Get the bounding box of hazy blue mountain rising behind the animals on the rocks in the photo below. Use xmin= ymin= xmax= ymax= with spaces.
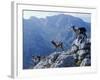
xmin=23 ymin=14 xmax=91 ymax=69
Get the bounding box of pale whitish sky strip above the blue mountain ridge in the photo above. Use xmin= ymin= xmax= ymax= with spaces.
xmin=23 ymin=10 xmax=91 ymax=23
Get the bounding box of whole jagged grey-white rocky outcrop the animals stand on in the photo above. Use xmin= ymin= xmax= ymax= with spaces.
xmin=33 ymin=39 xmax=91 ymax=69
